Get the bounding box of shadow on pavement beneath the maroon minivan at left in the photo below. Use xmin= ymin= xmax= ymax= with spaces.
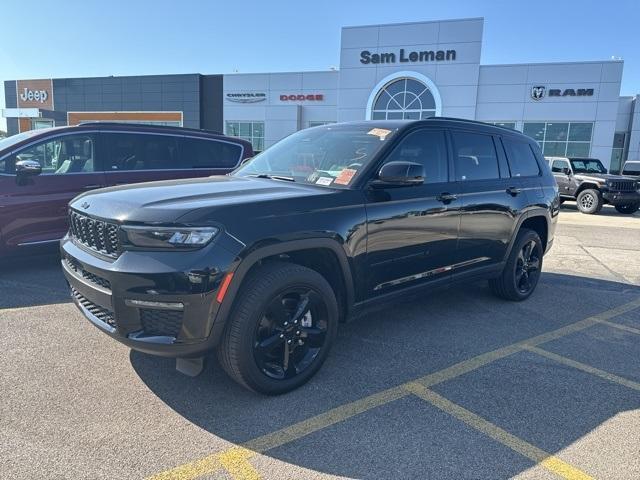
xmin=0 ymin=252 xmax=71 ymax=312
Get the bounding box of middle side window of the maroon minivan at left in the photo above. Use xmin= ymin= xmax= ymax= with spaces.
xmin=105 ymin=133 xmax=179 ymax=171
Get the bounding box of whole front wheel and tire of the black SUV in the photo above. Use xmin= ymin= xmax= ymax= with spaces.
xmin=218 ymin=262 xmax=338 ymax=395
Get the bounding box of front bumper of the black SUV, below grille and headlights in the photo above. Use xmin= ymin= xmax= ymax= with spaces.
xmin=60 ymin=237 xmax=235 ymax=357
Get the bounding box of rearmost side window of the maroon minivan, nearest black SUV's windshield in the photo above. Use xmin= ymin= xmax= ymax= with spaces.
xmin=180 ymin=138 xmax=242 ymax=168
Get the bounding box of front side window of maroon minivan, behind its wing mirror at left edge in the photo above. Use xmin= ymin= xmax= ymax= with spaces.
xmin=13 ymin=134 xmax=96 ymax=175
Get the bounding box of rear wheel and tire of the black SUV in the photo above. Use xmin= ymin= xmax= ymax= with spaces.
xmin=489 ymin=228 xmax=544 ymax=302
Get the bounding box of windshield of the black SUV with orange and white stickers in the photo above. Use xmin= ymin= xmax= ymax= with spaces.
xmin=233 ymin=123 xmax=396 ymax=187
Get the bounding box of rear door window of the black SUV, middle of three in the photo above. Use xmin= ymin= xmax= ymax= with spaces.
xmin=451 ymin=132 xmax=500 ymax=180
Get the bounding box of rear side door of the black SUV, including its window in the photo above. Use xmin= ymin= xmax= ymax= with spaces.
xmin=451 ymin=130 xmax=527 ymax=274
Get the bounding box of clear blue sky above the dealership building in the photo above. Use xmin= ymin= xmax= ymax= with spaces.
xmin=0 ymin=0 xmax=640 ymax=129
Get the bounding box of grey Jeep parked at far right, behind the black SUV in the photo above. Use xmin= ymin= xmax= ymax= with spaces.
xmin=546 ymin=157 xmax=640 ymax=214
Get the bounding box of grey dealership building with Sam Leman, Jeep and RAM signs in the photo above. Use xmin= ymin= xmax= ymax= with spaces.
xmin=3 ymin=18 xmax=640 ymax=171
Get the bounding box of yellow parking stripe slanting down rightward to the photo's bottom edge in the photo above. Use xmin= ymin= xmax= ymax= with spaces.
xmin=405 ymin=383 xmax=592 ymax=480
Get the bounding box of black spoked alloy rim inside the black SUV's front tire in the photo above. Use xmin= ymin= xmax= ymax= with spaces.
xmin=253 ymin=286 xmax=328 ymax=380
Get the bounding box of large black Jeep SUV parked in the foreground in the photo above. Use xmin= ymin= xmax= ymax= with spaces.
xmin=61 ymin=118 xmax=559 ymax=394
